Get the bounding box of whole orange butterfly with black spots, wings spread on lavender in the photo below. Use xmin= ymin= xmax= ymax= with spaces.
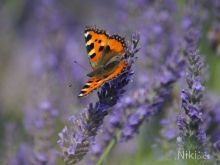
xmin=78 ymin=26 xmax=127 ymax=98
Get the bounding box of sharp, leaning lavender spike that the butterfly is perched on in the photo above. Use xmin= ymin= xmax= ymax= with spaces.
xmin=58 ymin=32 xmax=140 ymax=164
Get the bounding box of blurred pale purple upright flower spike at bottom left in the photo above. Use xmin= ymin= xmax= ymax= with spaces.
xmin=26 ymin=100 xmax=58 ymax=164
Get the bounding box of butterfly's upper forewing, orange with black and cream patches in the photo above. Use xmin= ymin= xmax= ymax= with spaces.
xmin=85 ymin=26 xmax=109 ymax=69
